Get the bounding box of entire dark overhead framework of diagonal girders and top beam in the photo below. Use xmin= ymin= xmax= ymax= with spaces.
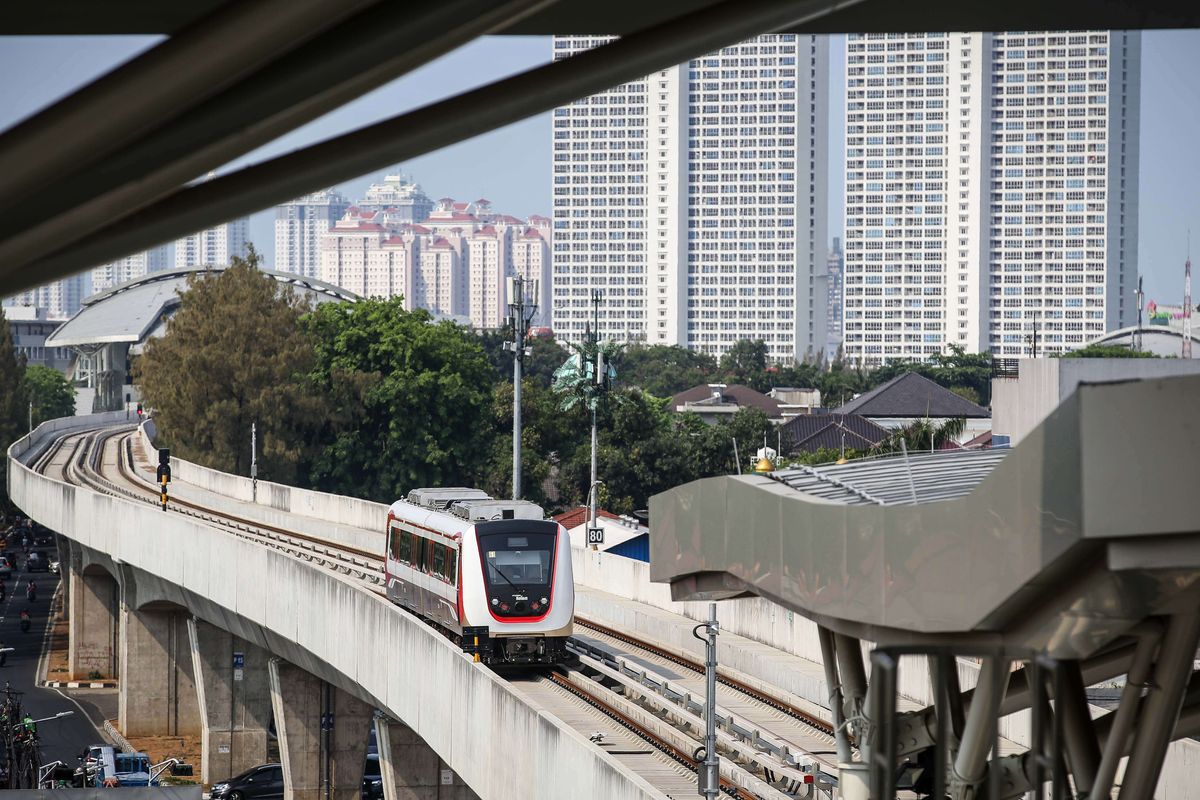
xmin=0 ymin=0 xmax=1200 ymax=302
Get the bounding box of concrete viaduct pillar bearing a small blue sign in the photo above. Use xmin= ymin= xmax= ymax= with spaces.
xmin=187 ymin=616 xmax=271 ymax=784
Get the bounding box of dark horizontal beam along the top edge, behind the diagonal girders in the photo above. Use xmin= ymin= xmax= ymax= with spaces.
xmin=7 ymin=0 xmax=1200 ymax=36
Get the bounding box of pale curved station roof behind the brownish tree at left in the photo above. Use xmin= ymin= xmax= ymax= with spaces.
xmin=46 ymin=266 xmax=359 ymax=347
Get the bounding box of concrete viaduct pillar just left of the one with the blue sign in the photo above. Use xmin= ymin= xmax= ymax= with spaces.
xmin=118 ymin=575 xmax=200 ymax=736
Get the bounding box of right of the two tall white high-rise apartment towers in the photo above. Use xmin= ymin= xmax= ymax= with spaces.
xmin=842 ymin=31 xmax=1141 ymax=365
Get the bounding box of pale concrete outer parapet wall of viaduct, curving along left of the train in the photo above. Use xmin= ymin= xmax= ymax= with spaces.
xmin=8 ymin=426 xmax=664 ymax=800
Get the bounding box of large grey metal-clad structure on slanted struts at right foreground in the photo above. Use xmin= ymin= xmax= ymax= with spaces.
xmin=650 ymin=377 xmax=1200 ymax=800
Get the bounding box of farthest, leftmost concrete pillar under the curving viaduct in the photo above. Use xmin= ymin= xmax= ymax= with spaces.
xmin=68 ymin=556 xmax=119 ymax=679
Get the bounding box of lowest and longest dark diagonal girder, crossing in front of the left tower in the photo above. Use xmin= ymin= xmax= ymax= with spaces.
xmin=0 ymin=0 xmax=858 ymax=293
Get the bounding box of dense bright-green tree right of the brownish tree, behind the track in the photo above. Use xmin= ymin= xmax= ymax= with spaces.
xmin=304 ymin=297 xmax=496 ymax=503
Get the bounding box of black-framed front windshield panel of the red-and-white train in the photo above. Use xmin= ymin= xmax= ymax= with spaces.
xmin=479 ymin=523 xmax=557 ymax=616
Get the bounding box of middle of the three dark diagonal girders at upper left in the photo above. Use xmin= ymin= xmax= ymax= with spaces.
xmin=0 ymin=0 xmax=551 ymax=271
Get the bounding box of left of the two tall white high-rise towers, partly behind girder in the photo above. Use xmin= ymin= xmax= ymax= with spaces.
xmin=553 ymin=34 xmax=828 ymax=361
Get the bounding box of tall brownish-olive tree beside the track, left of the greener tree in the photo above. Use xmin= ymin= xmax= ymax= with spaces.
xmin=134 ymin=249 xmax=328 ymax=483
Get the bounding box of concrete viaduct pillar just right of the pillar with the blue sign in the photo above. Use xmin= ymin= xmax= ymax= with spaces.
xmin=270 ymin=658 xmax=372 ymax=800
